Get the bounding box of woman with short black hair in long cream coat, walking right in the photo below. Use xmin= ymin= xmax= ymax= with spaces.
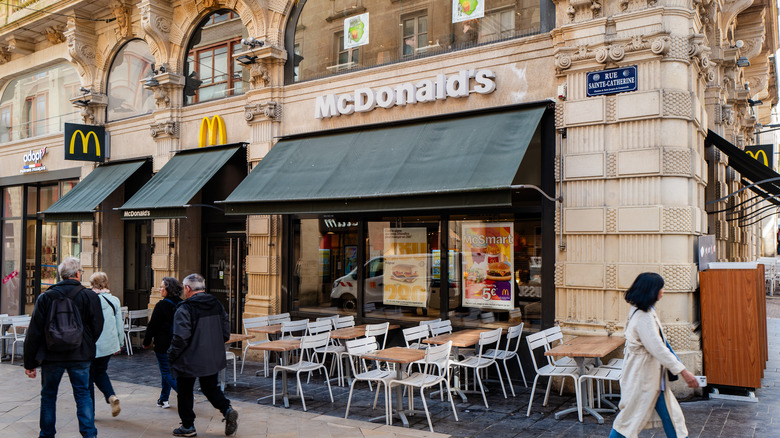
xmin=609 ymin=272 xmax=699 ymax=438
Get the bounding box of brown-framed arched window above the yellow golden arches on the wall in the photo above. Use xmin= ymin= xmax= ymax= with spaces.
xmin=184 ymin=9 xmax=249 ymax=105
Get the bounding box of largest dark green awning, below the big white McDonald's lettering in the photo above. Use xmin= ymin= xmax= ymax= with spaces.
xmin=222 ymin=104 xmax=547 ymax=214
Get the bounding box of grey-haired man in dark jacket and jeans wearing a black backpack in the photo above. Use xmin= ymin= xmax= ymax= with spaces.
xmin=24 ymin=257 xmax=103 ymax=438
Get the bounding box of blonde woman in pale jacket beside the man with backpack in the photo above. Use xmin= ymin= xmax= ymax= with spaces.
xmin=89 ymin=272 xmax=125 ymax=417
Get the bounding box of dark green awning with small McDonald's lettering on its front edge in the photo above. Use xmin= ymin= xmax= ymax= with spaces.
xmin=117 ymin=144 xmax=242 ymax=219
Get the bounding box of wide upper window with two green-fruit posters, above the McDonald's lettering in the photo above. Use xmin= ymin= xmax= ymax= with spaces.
xmin=285 ymin=0 xmax=545 ymax=83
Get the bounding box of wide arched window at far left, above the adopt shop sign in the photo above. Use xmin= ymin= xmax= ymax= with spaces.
xmin=0 ymin=62 xmax=81 ymax=143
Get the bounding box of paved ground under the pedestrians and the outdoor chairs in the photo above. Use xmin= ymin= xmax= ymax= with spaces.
xmin=0 ymin=302 xmax=780 ymax=438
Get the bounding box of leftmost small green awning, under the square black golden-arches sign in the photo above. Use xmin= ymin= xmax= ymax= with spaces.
xmin=43 ymin=160 xmax=146 ymax=222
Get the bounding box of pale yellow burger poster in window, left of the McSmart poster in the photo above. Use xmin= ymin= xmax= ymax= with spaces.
xmin=382 ymin=228 xmax=430 ymax=307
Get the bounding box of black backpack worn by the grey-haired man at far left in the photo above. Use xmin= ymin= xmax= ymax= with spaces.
xmin=46 ymin=287 xmax=84 ymax=352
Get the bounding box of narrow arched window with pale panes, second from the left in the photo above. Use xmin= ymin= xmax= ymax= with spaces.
xmin=106 ymin=40 xmax=154 ymax=122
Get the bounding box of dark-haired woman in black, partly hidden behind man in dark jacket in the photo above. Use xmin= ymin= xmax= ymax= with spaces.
xmin=144 ymin=277 xmax=183 ymax=409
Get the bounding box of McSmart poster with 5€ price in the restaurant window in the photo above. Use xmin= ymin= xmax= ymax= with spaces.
xmin=461 ymin=222 xmax=515 ymax=310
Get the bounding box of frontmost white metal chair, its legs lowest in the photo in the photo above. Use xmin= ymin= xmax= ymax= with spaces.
xmin=387 ymin=341 xmax=459 ymax=432
